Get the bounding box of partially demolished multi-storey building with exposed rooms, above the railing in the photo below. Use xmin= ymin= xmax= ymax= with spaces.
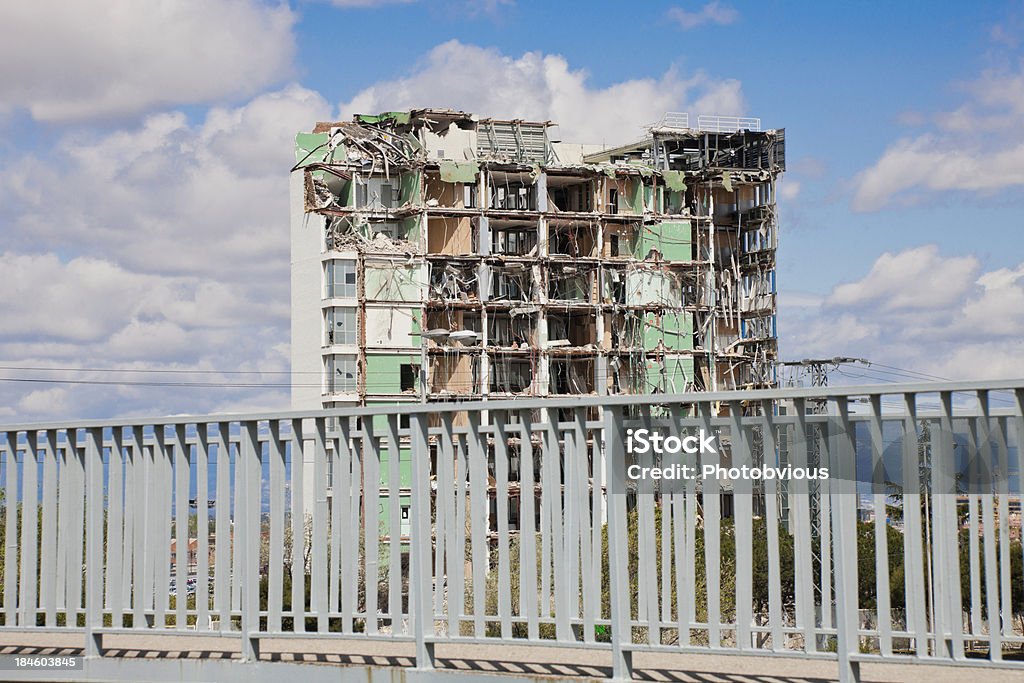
xmin=291 ymin=110 xmax=785 ymax=409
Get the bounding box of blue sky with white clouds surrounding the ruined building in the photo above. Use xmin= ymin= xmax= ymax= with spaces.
xmin=0 ymin=0 xmax=1024 ymax=422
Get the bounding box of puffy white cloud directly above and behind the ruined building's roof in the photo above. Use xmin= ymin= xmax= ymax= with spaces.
xmin=341 ymin=40 xmax=745 ymax=143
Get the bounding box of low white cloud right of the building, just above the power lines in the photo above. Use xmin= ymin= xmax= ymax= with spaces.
xmin=779 ymin=245 xmax=1024 ymax=381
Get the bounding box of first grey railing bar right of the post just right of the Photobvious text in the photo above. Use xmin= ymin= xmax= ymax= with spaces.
xmin=868 ymin=394 xmax=893 ymax=656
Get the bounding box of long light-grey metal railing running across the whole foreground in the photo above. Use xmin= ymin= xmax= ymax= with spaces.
xmin=0 ymin=381 xmax=1024 ymax=680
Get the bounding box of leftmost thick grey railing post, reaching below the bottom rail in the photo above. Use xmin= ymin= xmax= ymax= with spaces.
xmin=84 ymin=428 xmax=103 ymax=657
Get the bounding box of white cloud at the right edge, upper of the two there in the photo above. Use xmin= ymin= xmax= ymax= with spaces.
xmin=852 ymin=63 xmax=1024 ymax=211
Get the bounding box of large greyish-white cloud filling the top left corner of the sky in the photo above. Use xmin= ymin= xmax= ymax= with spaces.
xmin=0 ymin=0 xmax=296 ymax=122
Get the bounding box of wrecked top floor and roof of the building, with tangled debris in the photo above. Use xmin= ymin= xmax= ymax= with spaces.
xmin=295 ymin=109 xmax=785 ymax=178
